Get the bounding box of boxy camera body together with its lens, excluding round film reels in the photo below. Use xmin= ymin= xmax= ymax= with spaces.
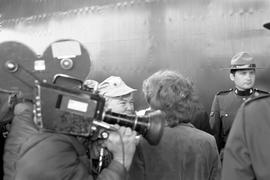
xmin=34 ymin=77 xmax=165 ymax=145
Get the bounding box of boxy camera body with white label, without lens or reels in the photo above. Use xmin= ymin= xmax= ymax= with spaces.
xmin=34 ymin=83 xmax=105 ymax=136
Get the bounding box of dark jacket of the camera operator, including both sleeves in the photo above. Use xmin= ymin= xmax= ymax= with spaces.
xmin=4 ymin=104 xmax=127 ymax=180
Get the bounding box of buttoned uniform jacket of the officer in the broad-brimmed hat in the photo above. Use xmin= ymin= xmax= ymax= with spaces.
xmin=209 ymin=89 xmax=268 ymax=151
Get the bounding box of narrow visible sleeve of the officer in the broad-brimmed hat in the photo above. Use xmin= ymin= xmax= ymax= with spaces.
xmin=209 ymin=95 xmax=225 ymax=151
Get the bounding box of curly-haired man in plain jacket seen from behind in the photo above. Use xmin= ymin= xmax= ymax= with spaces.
xmin=130 ymin=70 xmax=221 ymax=180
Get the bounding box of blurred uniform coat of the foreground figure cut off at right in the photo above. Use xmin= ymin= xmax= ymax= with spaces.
xmin=222 ymin=95 xmax=270 ymax=180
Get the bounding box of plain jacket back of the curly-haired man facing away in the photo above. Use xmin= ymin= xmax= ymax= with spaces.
xmin=130 ymin=123 xmax=220 ymax=180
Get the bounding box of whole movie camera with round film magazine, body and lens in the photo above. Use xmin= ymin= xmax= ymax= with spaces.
xmin=0 ymin=40 xmax=164 ymax=145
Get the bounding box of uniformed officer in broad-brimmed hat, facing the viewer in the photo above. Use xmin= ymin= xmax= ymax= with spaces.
xmin=209 ymin=52 xmax=268 ymax=159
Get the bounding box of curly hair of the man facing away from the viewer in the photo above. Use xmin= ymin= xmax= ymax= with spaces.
xmin=143 ymin=70 xmax=200 ymax=127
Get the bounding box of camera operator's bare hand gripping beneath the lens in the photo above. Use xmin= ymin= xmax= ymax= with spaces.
xmin=105 ymin=125 xmax=138 ymax=170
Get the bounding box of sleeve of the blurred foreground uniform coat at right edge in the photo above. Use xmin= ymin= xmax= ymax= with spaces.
xmin=222 ymin=105 xmax=256 ymax=180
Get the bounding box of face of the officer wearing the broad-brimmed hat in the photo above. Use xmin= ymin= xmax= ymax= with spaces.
xmin=230 ymin=69 xmax=255 ymax=90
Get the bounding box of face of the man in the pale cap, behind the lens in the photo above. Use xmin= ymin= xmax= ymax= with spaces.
xmin=105 ymin=93 xmax=135 ymax=114
